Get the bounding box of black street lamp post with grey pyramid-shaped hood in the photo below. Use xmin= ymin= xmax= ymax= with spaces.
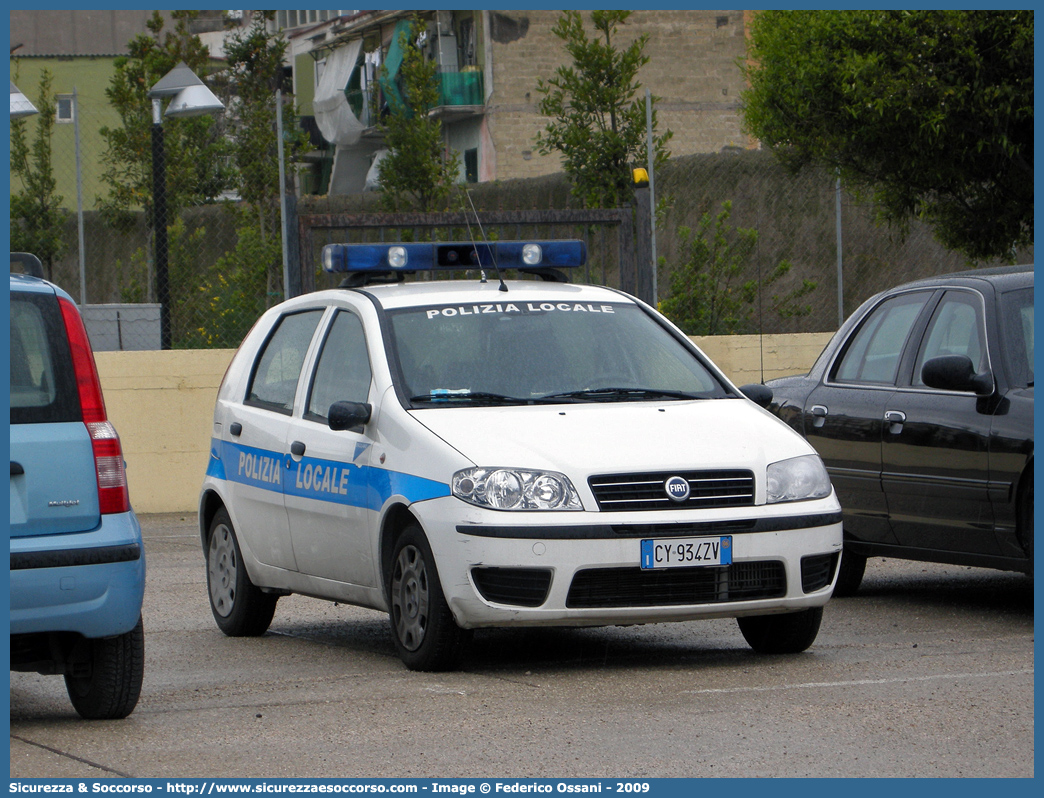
xmin=146 ymin=62 xmax=224 ymax=349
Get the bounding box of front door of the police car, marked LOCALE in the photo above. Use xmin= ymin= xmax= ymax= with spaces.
xmin=284 ymin=308 xmax=378 ymax=587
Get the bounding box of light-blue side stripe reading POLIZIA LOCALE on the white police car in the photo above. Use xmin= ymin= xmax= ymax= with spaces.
xmin=207 ymin=440 xmax=450 ymax=510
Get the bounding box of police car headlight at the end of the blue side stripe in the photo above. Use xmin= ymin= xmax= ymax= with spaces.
xmin=450 ymin=468 xmax=584 ymax=510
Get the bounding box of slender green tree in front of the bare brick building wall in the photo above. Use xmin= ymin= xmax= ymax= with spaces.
xmin=537 ymin=10 xmax=672 ymax=208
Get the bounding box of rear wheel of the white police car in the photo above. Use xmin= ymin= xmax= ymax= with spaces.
xmin=207 ymin=508 xmax=279 ymax=637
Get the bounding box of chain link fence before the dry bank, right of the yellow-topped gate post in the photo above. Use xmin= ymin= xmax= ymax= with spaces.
xmin=656 ymin=150 xmax=1033 ymax=334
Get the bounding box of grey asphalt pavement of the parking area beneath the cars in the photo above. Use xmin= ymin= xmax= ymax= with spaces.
xmin=10 ymin=515 xmax=1034 ymax=778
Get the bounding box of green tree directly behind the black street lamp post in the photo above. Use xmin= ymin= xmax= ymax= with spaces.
xmin=98 ymin=11 xmax=231 ymax=229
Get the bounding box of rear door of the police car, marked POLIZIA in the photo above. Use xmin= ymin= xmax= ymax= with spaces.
xmin=215 ymin=308 xmax=324 ymax=570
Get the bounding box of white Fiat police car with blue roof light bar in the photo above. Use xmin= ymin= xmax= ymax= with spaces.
xmin=199 ymin=241 xmax=841 ymax=670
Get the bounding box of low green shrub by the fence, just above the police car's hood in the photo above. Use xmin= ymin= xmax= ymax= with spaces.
xmin=660 ymin=201 xmax=816 ymax=335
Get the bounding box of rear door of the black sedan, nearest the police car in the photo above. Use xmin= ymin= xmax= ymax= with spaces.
xmin=803 ymin=291 xmax=931 ymax=543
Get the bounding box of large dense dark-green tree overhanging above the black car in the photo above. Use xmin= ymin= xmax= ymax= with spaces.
xmin=743 ymin=10 xmax=1034 ymax=259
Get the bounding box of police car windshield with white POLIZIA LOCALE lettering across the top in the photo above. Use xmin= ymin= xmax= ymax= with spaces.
xmin=388 ymin=301 xmax=729 ymax=407
